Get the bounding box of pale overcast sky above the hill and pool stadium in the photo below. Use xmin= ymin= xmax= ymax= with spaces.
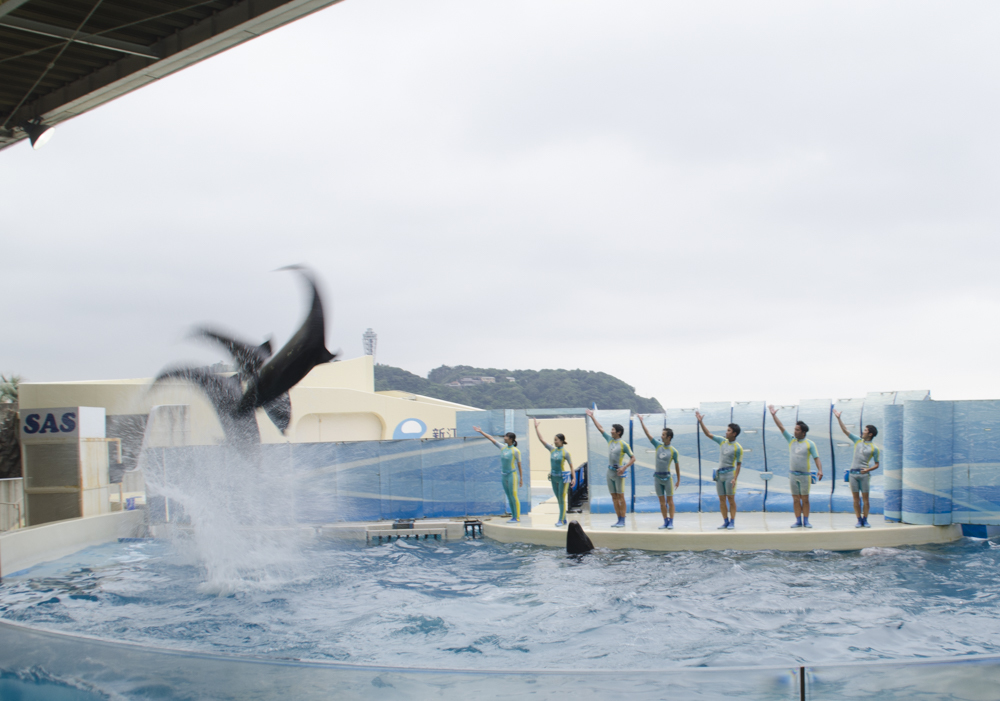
xmin=0 ymin=0 xmax=1000 ymax=408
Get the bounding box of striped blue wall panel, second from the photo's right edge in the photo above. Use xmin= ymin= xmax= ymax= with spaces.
xmin=901 ymin=401 xmax=955 ymax=526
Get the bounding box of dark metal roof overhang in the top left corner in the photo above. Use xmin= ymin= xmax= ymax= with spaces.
xmin=0 ymin=0 xmax=340 ymax=149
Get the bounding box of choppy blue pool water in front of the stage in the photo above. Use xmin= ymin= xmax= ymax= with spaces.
xmin=0 ymin=539 xmax=1000 ymax=670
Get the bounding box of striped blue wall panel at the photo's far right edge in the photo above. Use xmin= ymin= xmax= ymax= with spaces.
xmin=952 ymin=401 xmax=1000 ymax=526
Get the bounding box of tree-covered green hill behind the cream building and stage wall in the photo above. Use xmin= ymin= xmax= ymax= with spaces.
xmin=375 ymin=365 xmax=663 ymax=414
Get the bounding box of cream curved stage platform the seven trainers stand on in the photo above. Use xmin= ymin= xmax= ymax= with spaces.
xmin=483 ymin=499 xmax=962 ymax=551
